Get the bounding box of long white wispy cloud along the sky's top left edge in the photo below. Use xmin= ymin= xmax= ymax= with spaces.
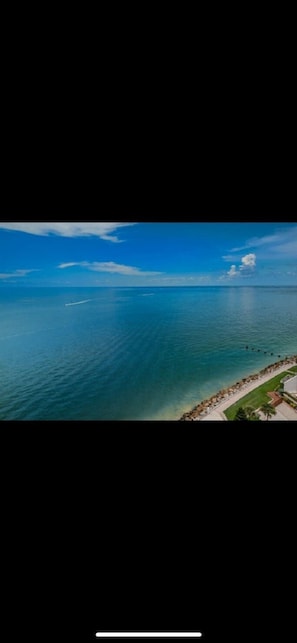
xmin=0 ymin=221 xmax=136 ymax=243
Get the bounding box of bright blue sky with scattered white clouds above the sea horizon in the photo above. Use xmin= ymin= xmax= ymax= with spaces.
xmin=0 ymin=222 xmax=297 ymax=286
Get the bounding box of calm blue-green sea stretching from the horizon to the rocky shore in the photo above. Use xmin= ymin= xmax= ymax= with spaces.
xmin=0 ymin=287 xmax=297 ymax=420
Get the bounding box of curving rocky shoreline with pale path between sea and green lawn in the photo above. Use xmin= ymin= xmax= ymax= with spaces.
xmin=178 ymin=355 xmax=297 ymax=422
